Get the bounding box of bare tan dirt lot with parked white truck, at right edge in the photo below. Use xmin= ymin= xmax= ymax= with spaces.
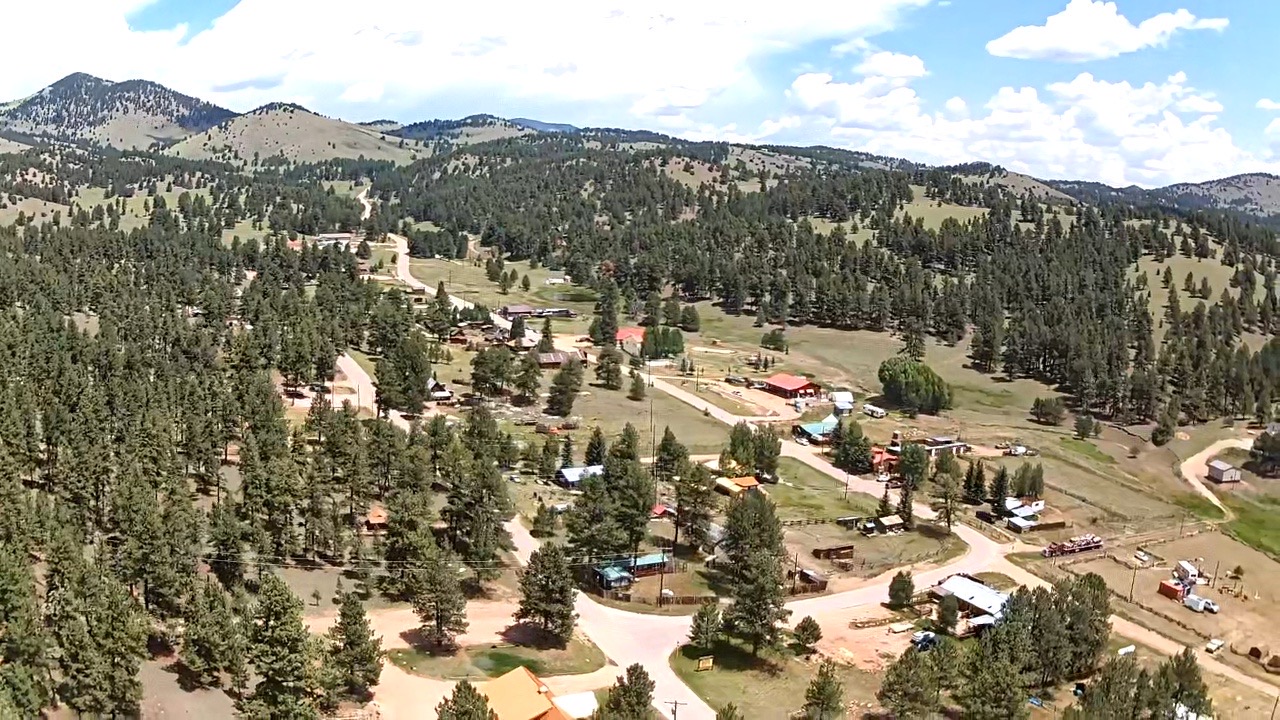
xmin=1071 ymin=532 xmax=1280 ymax=650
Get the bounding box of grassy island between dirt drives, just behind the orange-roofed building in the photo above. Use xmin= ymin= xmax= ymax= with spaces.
xmin=387 ymin=637 xmax=607 ymax=680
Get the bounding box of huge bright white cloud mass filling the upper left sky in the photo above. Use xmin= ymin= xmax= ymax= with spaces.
xmin=0 ymin=0 xmax=928 ymax=126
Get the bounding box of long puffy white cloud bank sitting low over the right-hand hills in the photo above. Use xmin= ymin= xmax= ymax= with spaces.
xmin=758 ymin=60 xmax=1264 ymax=187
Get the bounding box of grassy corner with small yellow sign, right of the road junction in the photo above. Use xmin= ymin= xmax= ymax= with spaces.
xmin=671 ymin=641 xmax=879 ymax=717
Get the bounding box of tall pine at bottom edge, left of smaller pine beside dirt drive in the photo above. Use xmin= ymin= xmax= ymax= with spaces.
xmin=244 ymin=574 xmax=319 ymax=719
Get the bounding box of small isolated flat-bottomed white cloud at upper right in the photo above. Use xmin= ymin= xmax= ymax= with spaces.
xmin=987 ymin=0 xmax=1228 ymax=63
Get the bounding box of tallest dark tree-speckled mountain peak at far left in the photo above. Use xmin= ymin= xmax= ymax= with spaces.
xmin=0 ymin=73 xmax=236 ymax=150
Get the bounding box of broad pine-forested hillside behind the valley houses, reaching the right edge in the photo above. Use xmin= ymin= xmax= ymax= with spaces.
xmin=347 ymin=136 xmax=1280 ymax=432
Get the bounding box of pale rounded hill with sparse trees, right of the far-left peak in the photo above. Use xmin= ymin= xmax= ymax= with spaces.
xmin=166 ymin=102 xmax=431 ymax=163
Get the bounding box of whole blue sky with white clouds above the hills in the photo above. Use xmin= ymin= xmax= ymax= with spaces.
xmin=0 ymin=0 xmax=1280 ymax=187
